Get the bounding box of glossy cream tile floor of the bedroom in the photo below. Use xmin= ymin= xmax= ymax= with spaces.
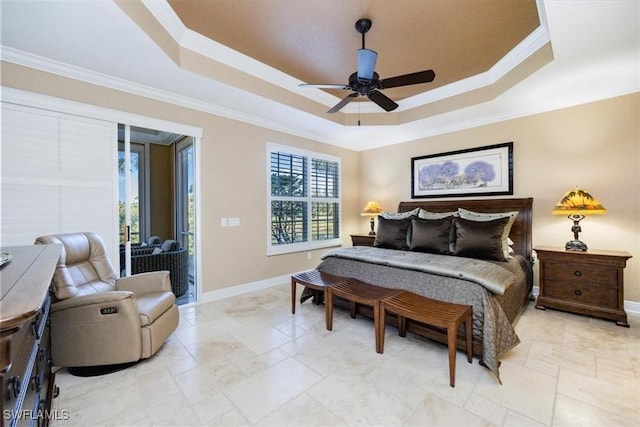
xmin=52 ymin=285 xmax=640 ymax=426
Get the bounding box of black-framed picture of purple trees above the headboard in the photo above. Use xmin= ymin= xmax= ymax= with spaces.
xmin=411 ymin=142 xmax=513 ymax=199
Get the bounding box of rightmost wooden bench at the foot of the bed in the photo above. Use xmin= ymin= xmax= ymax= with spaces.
xmin=374 ymin=291 xmax=473 ymax=387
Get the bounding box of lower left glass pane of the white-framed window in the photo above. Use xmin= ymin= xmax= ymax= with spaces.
xmin=271 ymin=201 xmax=307 ymax=245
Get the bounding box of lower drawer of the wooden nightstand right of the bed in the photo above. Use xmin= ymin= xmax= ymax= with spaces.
xmin=544 ymin=280 xmax=618 ymax=309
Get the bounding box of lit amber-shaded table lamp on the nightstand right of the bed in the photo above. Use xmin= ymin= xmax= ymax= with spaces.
xmin=551 ymin=188 xmax=607 ymax=251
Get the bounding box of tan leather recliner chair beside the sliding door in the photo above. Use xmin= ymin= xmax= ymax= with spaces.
xmin=36 ymin=232 xmax=179 ymax=367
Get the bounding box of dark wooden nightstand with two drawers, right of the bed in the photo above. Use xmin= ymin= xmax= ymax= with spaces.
xmin=534 ymin=246 xmax=631 ymax=327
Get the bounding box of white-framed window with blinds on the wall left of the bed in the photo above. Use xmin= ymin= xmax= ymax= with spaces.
xmin=267 ymin=144 xmax=341 ymax=255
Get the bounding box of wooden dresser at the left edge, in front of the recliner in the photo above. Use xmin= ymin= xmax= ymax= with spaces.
xmin=0 ymin=245 xmax=62 ymax=426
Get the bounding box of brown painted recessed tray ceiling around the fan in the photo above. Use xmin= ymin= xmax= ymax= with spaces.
xmin=169 ymin=0 xmax=540 ymax=100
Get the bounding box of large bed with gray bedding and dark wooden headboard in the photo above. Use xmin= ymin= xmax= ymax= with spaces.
xmin=310 ymin=198 xmax=533 ymax=378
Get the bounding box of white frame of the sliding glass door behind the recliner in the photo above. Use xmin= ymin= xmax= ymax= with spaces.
xmin=2 ymin=87 xmax=203 ymax=301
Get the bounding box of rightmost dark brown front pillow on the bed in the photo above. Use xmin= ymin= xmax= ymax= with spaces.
xmin=453 ymin=217 xmax=509 ymax=261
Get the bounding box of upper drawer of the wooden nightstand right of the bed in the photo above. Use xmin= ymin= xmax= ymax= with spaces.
xmin=542 ymin=262 xmax=618 ymax=288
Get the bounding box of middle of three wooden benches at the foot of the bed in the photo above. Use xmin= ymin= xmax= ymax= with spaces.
xmin=325 ymin=278 xmax=400 ymax=353
